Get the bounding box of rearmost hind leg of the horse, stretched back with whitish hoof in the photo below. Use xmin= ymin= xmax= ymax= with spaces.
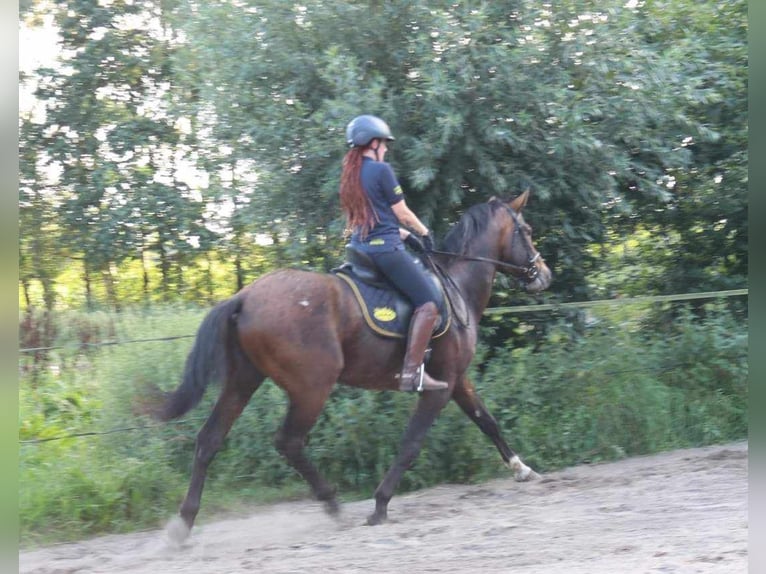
xmin=168 ymin=375 xmax=263 ymax=543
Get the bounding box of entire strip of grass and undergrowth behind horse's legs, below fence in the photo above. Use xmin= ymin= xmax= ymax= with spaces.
xmin=19 ymin=304 xmax=748 ymax=544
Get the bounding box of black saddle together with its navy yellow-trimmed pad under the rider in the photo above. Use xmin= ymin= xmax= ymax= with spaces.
xmin=331 ymin=245 xmax=452 ymax=339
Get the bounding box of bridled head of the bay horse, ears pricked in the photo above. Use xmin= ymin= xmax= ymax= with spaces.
xmin=498 ymin=190 xmax=553 ymax=293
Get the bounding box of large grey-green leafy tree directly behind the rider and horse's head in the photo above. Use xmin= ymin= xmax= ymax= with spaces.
xmin=170 ymin=1 xmax=745 ymax=299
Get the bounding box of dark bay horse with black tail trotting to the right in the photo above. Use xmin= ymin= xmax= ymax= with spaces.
xmin=154 ymin=191 xmax=551 ymax=541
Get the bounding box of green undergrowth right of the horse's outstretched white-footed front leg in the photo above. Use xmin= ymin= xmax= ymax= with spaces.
xmin=480 ymin=306 xmax=747 ymax=470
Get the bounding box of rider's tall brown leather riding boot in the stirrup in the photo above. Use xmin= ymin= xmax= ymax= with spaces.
xmin=399 ymin=302 xmax=449 ymax=392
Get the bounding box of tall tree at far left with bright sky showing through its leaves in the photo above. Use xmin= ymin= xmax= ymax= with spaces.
xmin=25 ymin=0 xmax=212 ymax=305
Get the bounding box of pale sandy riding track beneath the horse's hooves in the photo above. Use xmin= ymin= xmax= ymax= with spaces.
xmin=19 ymin=442 xmax=748 ymax=574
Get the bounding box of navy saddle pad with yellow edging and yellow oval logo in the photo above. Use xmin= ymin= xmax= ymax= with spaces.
xmin=333 ymin=268 xmax=451 ymax=339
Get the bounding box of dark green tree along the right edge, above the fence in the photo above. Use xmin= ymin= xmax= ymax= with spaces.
xmin=641 ymin=1 xmax=748 ymax=292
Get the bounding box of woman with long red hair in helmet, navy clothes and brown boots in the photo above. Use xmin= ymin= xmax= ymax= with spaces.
xmin=340 ymin=115 xmax=448 ymax=391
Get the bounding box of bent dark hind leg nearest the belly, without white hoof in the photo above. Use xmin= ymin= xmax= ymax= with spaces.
xmin=274 ymin=381 xmax=339 ymax=514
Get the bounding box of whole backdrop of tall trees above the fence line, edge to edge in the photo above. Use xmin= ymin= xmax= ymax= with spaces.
xmin=19 ymin=0 xmax=748 ymax=316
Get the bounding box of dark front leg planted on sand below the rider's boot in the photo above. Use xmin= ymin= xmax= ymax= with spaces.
xmin=367 ymin=390 xmax=449 ymax=526
